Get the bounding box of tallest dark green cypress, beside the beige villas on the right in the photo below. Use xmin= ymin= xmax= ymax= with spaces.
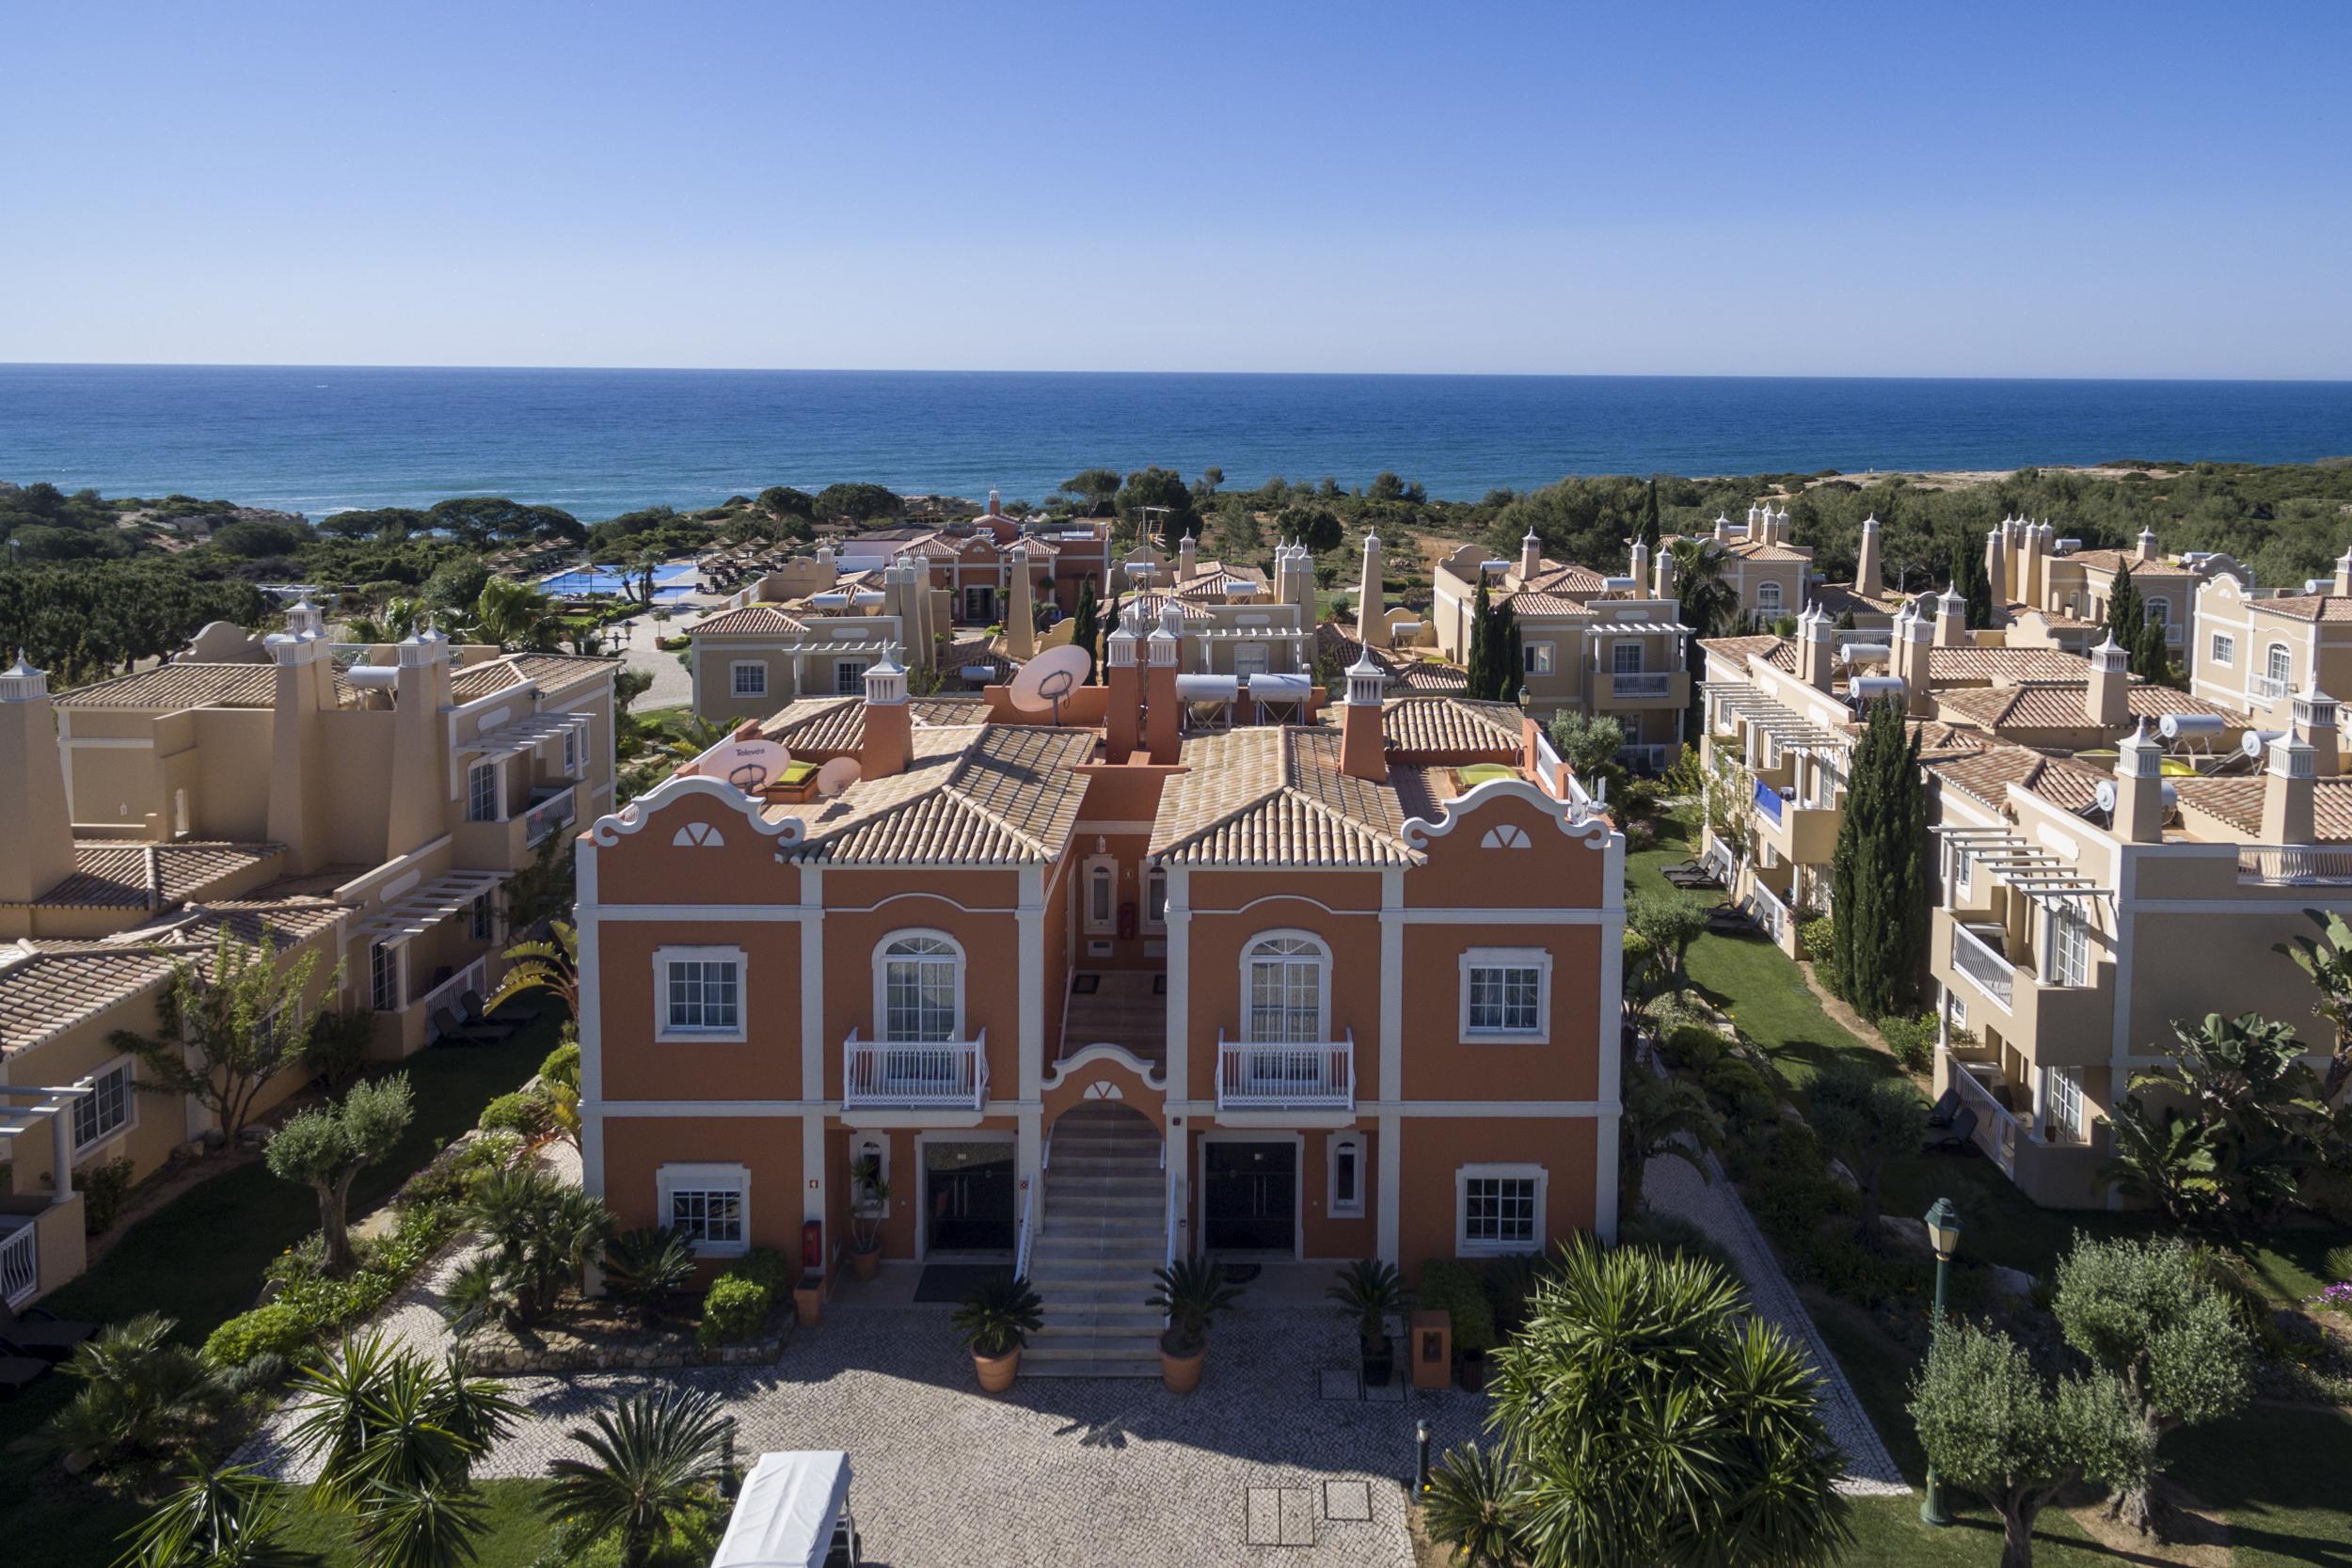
xmin=1830 ymin=701 xmax=1929 ymax=1018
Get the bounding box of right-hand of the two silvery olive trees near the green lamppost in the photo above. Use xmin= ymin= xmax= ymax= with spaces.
xmin=2051 ymin=1237 xmax=2253 ymax=1533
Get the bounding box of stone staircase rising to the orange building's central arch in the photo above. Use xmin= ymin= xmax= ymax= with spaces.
xmin=1021 ymin=1102 xmax=1167 ymax=1378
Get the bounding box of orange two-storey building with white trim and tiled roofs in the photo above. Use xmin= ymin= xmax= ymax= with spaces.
xmin=579 ymin=613 xmax=1623 ymax=1370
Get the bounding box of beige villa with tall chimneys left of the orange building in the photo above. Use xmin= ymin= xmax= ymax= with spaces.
xmin=0 ymin=604 xmax=619 ymax=1305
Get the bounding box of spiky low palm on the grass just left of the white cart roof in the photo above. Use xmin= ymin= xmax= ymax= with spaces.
xmin=539 ymin=1385 xmax=727 ymax=1568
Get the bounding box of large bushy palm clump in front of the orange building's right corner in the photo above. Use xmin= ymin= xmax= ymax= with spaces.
xmin=1486 ymin=1239 xmax=1853 ymax=1568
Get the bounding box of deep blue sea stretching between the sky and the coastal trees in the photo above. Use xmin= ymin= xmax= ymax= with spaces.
xmin=0 ymin=364 xmax=2352 ymax=519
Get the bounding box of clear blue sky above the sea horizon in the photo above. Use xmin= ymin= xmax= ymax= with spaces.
xmin=0 ymin=0 xmax=2352 ymax=378
